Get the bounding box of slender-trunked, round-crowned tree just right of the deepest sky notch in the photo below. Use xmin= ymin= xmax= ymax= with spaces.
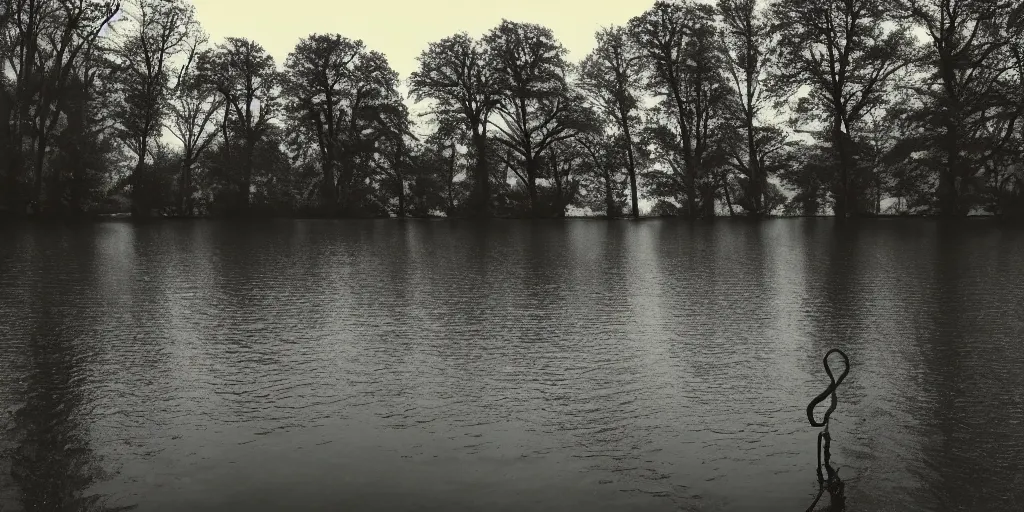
xmin=410 ymin=33 xmax=499 ymax=216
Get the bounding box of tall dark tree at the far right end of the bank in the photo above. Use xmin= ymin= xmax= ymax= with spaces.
xmin=897 ymin=0 xmax=1024 ymax=215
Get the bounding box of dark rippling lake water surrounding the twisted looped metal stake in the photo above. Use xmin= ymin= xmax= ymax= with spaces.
xmin=0 ymin=219 xmax=1024 ymax=511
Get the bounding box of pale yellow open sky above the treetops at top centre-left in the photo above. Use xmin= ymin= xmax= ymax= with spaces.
xmin=191 ymin=0 xmax=654 ymax=91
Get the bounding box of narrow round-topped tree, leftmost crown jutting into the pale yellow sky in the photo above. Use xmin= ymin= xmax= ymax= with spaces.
xmin=201 ymin=37 xmax=281 ymax=211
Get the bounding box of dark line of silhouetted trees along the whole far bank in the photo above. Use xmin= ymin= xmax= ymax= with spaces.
xmin=0 ymin=0 xmax=1024 ymax=219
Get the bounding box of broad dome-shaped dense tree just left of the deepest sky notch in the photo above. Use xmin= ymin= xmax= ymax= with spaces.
xmin=283 ymin=34 xmax=409 ymax=215
